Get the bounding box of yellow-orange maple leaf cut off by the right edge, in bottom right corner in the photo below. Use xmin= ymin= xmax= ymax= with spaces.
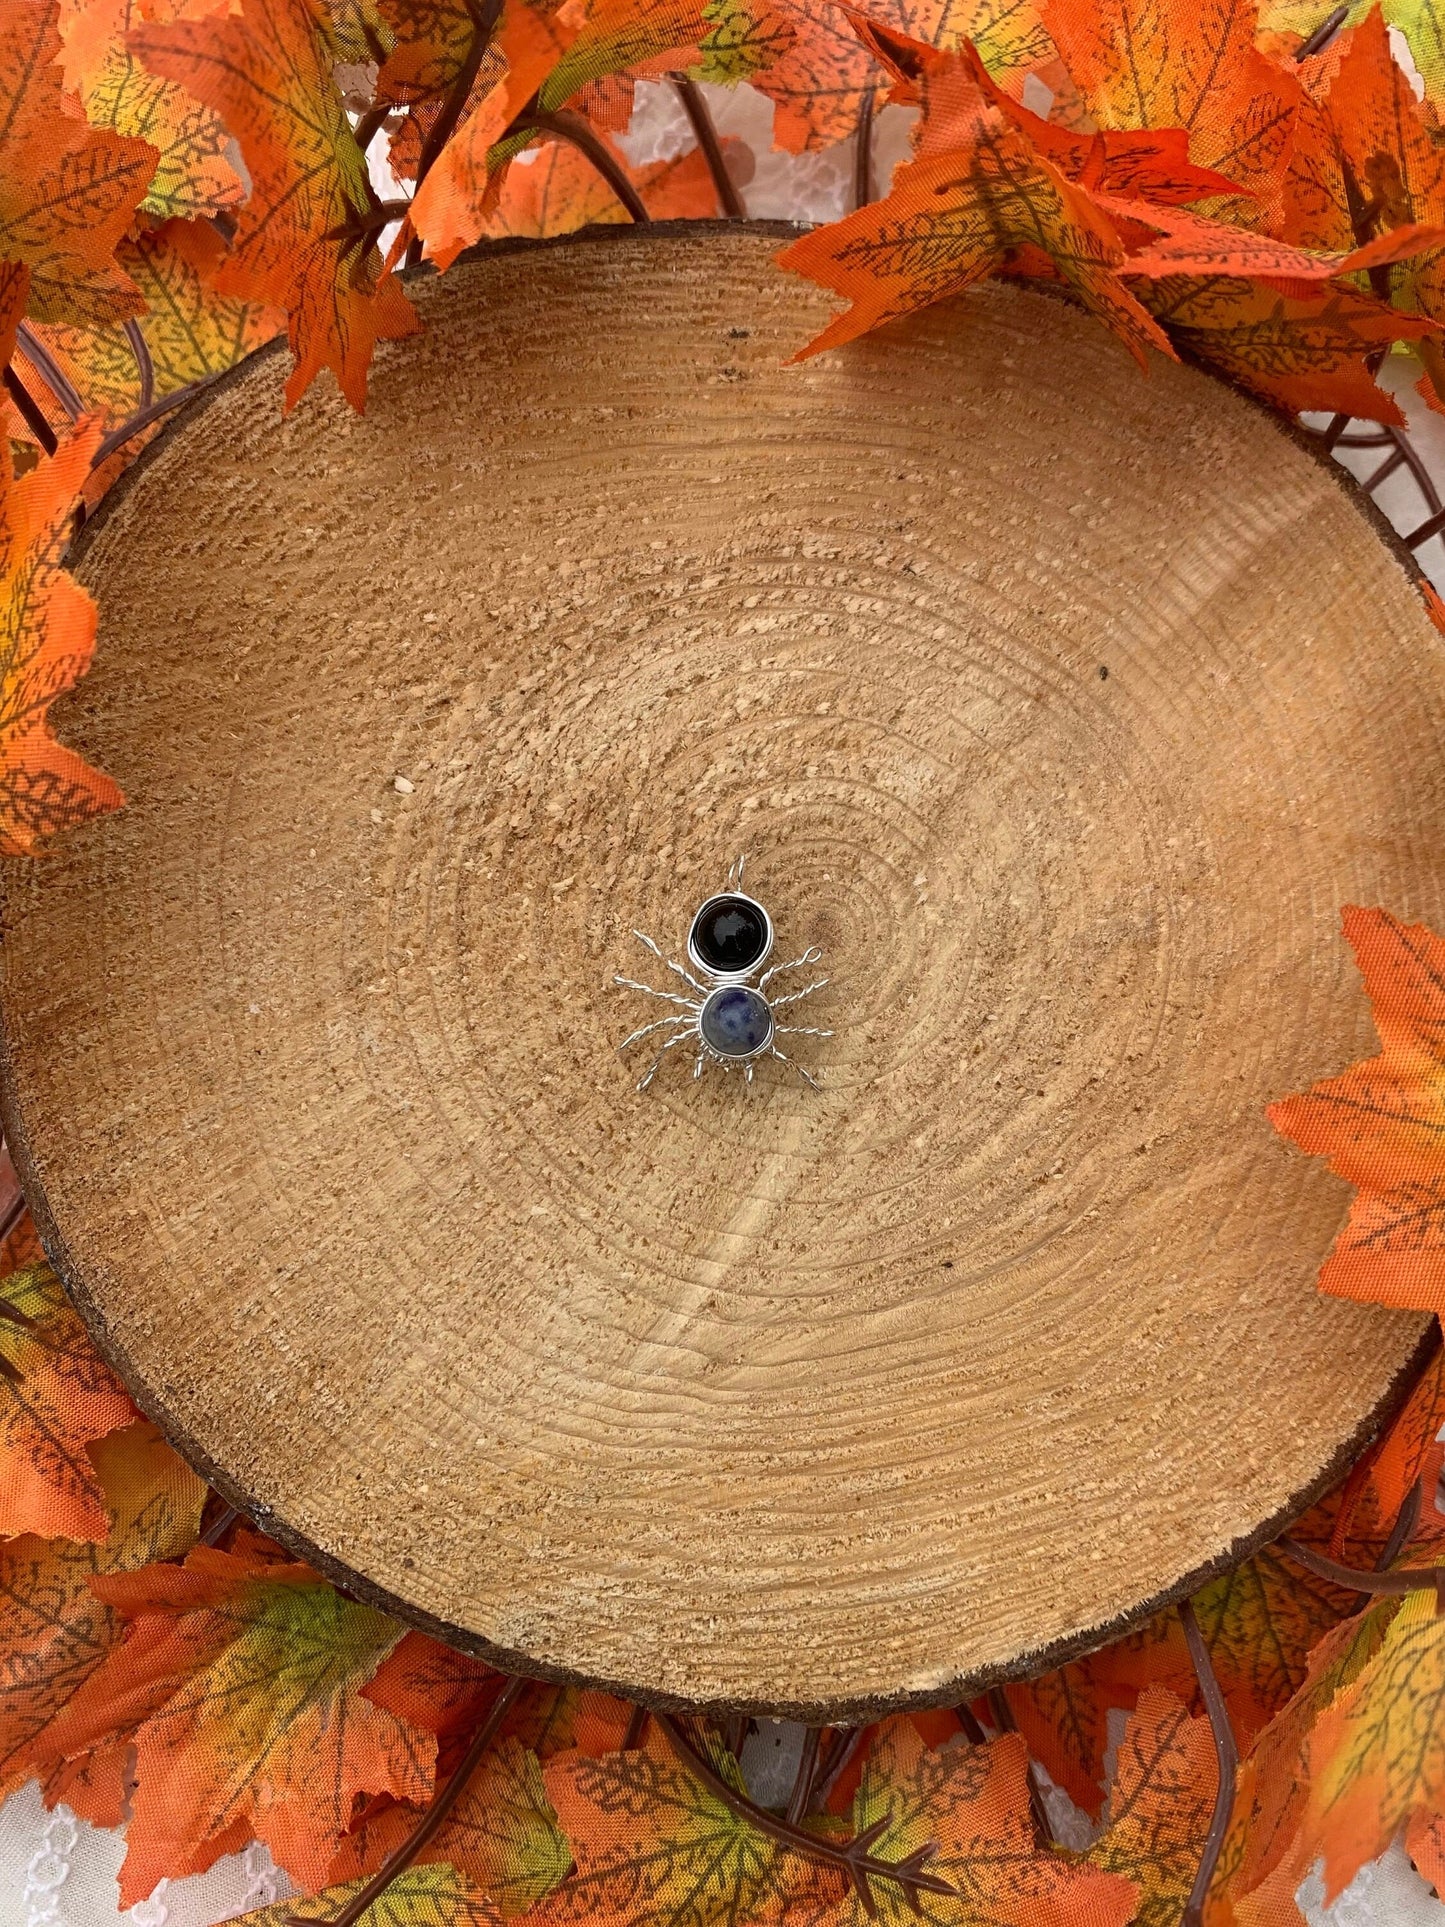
xmin=1302 ymin=1586 xmax=1445 ymax=1900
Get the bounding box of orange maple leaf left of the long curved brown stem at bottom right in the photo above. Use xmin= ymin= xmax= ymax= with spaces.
xmin=1087 ymin=1686 xmax=1220 ymax=1927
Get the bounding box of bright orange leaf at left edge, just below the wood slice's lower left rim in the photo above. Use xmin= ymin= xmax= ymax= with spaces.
xmin=0 ymin=1264 xmax=135 ymax=1540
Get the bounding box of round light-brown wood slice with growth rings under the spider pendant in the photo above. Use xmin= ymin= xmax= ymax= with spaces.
xmin=4 ymin=225 xmax=1445 ymax=1719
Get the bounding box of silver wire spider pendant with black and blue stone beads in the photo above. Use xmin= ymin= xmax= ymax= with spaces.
xmin=613 ymin=858 xmax=832 ymax=1091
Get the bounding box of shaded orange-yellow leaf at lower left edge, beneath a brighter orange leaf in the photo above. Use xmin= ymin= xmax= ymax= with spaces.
xmin=0 ymin=1420 xmax=206 ymax=1788
